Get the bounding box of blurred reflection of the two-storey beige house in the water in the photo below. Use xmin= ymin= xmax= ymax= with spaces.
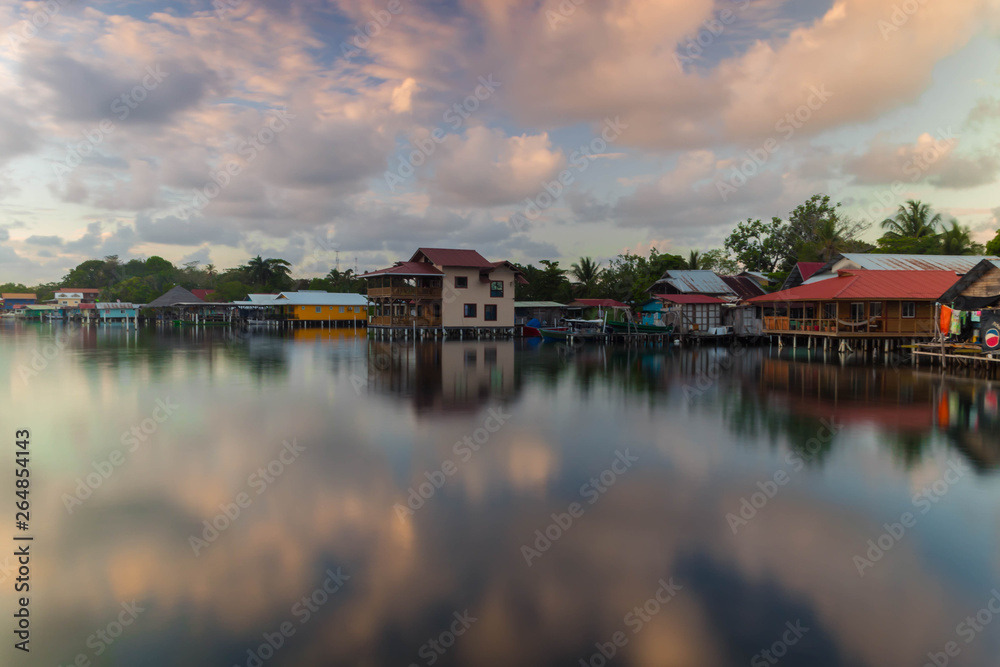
xmin=368 ymin=340 xmax=520 ymax=412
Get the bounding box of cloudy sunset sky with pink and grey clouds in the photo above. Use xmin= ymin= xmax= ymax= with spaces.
xmin=0 ymin=0 xmax=1000 ymax=285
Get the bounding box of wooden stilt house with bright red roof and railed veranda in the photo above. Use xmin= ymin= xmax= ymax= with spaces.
xmin=750 ymin=270 xmax=958 ymax=338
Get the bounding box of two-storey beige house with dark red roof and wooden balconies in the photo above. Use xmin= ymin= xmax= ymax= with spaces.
xmin=361 ymin=248 xmax=526 ymax=329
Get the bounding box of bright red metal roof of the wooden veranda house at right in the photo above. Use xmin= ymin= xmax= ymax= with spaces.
xmin=750 ymin=270 xmax=958 ymax=303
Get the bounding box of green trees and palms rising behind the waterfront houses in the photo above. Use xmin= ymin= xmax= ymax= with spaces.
xmin=0 ymin=194 xmax=1000 ymax=304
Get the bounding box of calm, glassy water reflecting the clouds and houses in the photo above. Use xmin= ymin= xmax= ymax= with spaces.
xmin=0 ymin=325 xmax=1000 ymax=667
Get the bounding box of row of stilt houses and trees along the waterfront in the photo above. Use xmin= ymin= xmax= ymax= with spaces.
xmin=0 ymin=196 xmax=1000 ymax=372
